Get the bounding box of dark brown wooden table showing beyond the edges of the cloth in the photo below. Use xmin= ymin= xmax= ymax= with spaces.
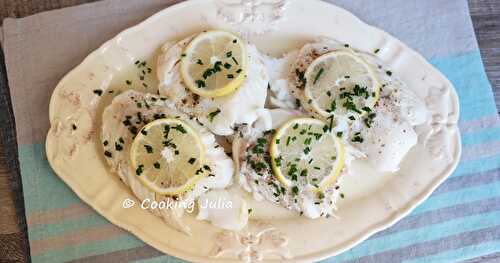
xmin=0 ymin=0 xmax=500 ymax=262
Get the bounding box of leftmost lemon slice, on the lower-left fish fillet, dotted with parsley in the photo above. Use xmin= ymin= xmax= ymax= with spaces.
xmin=130 ymin=118 xmax=209 ymax=195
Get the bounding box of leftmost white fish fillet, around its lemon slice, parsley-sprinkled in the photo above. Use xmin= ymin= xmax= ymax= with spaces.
xmin=101 ymin=90 xmax=234 ymax=234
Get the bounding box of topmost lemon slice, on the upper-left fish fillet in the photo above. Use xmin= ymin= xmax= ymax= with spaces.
xmin=181 ymin=31 xmax=247 ymax=97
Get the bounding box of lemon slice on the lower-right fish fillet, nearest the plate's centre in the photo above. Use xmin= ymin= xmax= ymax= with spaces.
xmin=269 ymin=118 xmax=344 ymax=192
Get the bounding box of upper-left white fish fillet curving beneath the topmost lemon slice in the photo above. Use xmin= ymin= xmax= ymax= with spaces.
xmin=157 ymin=37 xmax=269 ymax=135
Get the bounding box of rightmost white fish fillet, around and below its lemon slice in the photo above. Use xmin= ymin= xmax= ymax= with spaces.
xmin=289 ymin=39 xmax=429 ymax=172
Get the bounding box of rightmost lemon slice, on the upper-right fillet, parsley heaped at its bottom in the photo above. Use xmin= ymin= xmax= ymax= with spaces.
xmin=304 ymin=50 xmax=380 ymax=119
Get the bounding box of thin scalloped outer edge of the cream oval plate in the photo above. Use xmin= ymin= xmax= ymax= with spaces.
xmin=45 ymin=0 xmax=462 ymax=262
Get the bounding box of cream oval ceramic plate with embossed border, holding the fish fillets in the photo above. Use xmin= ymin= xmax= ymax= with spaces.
xmin=46 ymin=0 xmax=461 ymax=262
